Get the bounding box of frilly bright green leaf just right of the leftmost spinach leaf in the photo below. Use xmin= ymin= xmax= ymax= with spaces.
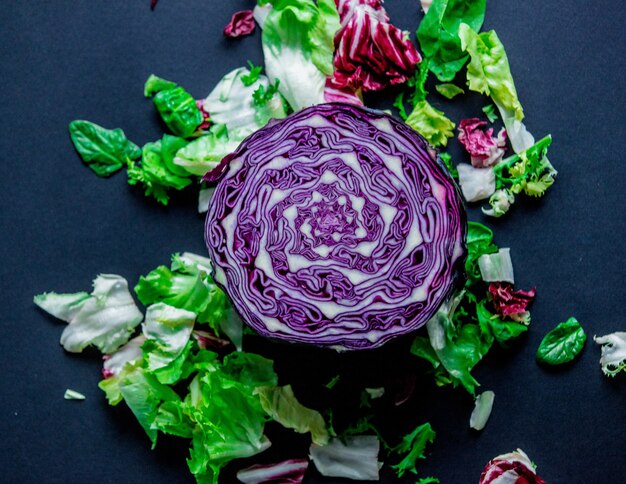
xmin=128 ymin=140 xmax=191 ymax=205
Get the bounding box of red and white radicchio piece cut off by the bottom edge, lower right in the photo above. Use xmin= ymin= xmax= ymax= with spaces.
xmin=478 ymin=449 xmax=546 ymax=484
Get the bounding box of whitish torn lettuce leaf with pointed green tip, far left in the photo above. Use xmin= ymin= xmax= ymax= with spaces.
xmin=34 ymin=274 xmax=143 ymax=353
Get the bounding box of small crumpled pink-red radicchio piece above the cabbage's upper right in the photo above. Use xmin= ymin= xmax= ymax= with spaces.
xmin=459 ymin=118 xmax=506 ymax=168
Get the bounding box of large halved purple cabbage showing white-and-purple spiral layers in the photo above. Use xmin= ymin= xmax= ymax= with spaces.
xmin=206 ymin=103 xmax=466 ymax=349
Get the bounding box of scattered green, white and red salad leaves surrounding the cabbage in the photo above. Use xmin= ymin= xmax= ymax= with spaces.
xmin=35 ymin=0 xmax=626 ymax=484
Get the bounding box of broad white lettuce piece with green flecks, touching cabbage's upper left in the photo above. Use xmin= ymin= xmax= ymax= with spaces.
xmin=201 ymin=67 xmax=287 ymax=140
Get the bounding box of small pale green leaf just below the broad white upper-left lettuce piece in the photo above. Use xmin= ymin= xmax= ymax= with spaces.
xmin=174 ymin=124 xmax=243 ymax=176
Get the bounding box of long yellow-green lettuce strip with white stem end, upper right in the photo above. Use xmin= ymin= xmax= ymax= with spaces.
xmin=459 ymin=24 xmax=535 ymax=153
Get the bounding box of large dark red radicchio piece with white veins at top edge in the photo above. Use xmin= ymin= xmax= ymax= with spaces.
xmin=332 ymin=0 xmax=421 ymax=91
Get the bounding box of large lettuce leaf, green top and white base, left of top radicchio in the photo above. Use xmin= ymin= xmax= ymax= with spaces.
xmin=262 ymin=0 xmax=339 ymax=111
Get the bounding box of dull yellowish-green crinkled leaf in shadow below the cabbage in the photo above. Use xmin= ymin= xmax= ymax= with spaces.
xmin=255 ymin=385 xmax=329 ymax=445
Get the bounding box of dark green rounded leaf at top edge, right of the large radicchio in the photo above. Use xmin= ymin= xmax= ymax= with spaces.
xmin=417 ymin=0 xmax=485 ymax=82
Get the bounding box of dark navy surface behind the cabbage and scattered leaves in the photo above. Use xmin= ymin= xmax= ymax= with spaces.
xmin=0 ymin=0 xmax=626 ymax=484
